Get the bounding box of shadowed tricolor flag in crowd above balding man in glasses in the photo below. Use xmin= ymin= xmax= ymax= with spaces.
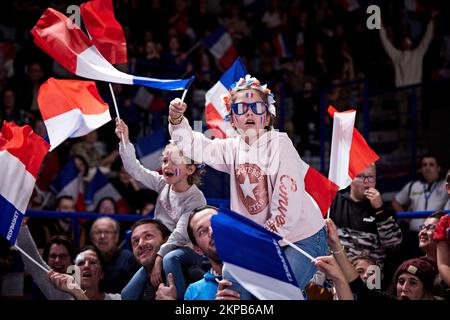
xmin=85 ymin=169 xmax=129 ymax=213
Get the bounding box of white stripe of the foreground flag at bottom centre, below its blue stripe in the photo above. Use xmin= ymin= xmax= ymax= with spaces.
xmin=226 ymin=263 xmax=304 ymax=300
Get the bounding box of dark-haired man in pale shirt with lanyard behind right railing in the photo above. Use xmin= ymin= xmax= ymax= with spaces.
xmin=392 ymin=153 xmax=448 ymax=231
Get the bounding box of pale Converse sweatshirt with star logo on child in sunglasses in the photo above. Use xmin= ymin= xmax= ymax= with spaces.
xmin=169 ymin=118 xmax=325 ymax=244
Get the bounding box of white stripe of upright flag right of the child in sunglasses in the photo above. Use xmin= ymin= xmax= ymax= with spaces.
xmin=328 ymin=111 xmax=356 ymax=189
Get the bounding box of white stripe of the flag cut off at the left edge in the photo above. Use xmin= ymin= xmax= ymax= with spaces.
xmin=0 ymin=150 xmax=36 ymax=214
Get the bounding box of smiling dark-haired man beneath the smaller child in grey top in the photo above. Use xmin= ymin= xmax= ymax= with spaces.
xmin=121 ymin=218 xmax=170 ymax=300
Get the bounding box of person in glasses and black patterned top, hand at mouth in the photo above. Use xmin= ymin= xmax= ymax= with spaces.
xmin=330 ymin=164 xmax=402 ymax=272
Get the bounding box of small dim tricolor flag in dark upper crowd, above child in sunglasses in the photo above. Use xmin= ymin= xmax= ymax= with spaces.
xmin=203 ymin=27 xmax=238 ymax=69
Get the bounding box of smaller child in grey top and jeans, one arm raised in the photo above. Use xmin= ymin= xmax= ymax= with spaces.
xmin=116 ymin=119 xmax=206 ymax=299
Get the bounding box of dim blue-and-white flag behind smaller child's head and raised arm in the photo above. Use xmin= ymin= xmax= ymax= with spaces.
xmin=136 ymin=129 xmax=167 ymax=171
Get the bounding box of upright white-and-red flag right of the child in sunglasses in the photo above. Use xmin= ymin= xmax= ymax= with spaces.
xmin=328 ymin=106 xmax=380 ymax=189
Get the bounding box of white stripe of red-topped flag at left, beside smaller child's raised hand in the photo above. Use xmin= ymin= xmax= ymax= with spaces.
xmin=44 ymin=108 xmax=111 ymax=151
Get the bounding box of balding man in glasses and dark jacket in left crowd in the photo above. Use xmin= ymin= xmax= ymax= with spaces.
xmin=90 ymin=217 xmax=139 ymax=293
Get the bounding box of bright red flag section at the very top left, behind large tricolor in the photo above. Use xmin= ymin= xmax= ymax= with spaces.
xmin=80 ymin=0 xmax=127 ymax=64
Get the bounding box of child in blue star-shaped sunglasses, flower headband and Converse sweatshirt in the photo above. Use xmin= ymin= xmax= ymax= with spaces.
xmin=169 ymin=75 xmax=328 ymax=299
